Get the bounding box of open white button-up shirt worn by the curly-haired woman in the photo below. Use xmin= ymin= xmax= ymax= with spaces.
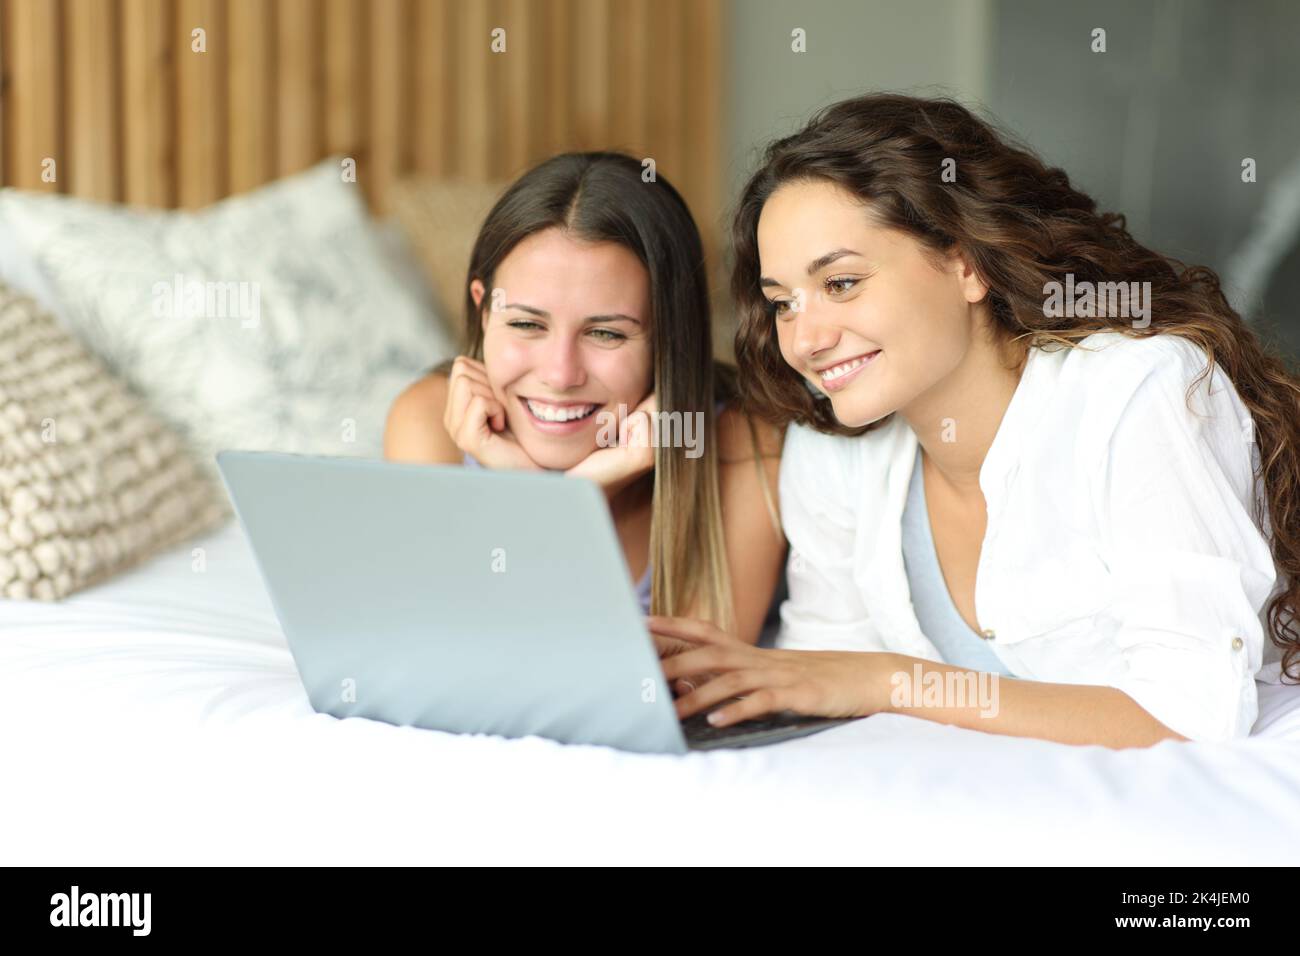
xmin=777 ymin=333 xmax=1281 ymax=740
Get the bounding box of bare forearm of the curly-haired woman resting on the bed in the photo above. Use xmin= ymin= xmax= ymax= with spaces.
xmin=887 ymin=654 xmax=1187 ymax=748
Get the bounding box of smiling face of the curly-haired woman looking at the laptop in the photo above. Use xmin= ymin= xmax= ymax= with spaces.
xmin=758 ymin=179 xmax=988 ymax=427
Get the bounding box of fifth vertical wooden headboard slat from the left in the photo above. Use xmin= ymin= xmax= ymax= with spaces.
xmin=226 ymin=0 xmax=277 ymax=193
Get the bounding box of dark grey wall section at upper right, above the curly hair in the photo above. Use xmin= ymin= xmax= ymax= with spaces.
xmin=988 ymin=0 xmax=1300 ymax=355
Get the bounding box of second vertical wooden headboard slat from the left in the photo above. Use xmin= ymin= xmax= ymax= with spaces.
xmin=64 ymin=0 xmax=122 ymax=203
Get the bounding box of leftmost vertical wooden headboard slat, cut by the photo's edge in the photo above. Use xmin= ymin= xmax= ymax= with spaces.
xmin=3 ymin=0 xmax=68 ymax=193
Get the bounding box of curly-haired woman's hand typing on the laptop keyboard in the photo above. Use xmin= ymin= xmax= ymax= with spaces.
xmin=646 ymin=615 xmax=892 ymax=727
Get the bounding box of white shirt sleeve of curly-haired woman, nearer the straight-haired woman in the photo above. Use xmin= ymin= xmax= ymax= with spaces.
xmin=776 ymin=425 xmax=885 ymax=650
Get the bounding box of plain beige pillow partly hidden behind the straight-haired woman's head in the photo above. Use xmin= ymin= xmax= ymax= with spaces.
xmin=391 ymin=179 xmax=508 ymax=346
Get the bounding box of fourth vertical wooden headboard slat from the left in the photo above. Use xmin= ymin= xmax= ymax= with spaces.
xmin=176 ymin=0 xmax=229 ymax=208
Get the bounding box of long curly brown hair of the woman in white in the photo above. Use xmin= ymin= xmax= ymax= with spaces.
xmin=732 ymin=94 xmax=1300 ymax=680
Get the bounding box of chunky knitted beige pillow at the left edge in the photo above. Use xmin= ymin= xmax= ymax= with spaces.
xmin=0 ymin=285 xmax=231 ymax=601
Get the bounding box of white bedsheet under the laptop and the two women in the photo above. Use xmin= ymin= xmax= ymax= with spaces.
xmin=0 ymin=520 xmax=1300 ymax=865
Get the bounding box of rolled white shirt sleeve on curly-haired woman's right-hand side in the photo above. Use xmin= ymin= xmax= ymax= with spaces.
xmin=1097 ymin=336 xmax=1277 ymax=740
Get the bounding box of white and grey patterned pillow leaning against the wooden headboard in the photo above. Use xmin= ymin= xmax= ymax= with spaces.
xmin=0 ymin=160 xmax=451 ymax=475
